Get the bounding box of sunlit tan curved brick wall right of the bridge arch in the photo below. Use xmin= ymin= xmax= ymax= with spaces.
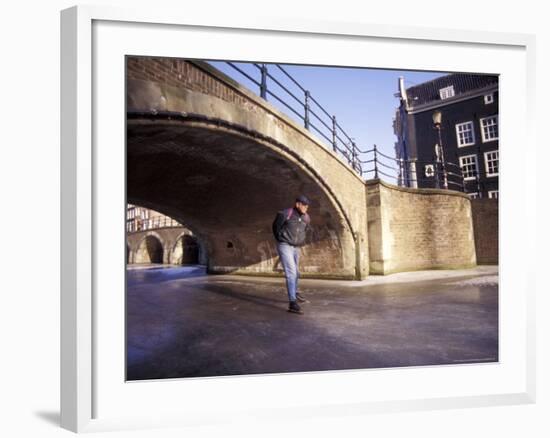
xmin=367 ymin=180 xmax=476 ymax=274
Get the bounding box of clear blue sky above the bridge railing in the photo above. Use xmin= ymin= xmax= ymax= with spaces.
xmin=211 ymin=62 xmax=445 ymax=166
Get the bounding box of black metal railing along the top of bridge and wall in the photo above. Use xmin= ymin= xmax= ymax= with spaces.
xmin=220 ymin=62 xmax=470 ymax=191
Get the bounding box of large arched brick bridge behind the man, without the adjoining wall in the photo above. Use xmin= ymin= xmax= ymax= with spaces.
xmin=127 ymin=61 xmax=368 ymax=278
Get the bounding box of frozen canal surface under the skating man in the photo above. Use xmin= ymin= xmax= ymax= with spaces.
xmin=126 ymin=266 xmax=498 ymax=380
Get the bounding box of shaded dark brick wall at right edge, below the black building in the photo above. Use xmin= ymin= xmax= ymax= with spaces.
xmin=472 ymin=198 xmax=498 ymax=265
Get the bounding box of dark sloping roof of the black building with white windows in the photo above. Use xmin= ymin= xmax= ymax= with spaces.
xmin=407 ymin=73 xmax=498 ymax=108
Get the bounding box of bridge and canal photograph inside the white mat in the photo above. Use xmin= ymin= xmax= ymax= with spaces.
xmin=125 ymin=54 xmax=499 ymax=381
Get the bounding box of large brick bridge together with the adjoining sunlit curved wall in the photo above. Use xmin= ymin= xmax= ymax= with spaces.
xmin=127 ymin=57 xmax=475 ymax=279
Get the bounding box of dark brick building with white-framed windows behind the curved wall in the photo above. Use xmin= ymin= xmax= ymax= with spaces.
xmin=394 ymin=73 xmax=499 ymax=198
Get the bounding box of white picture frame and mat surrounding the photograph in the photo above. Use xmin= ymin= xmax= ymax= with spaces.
xmin=61 ymin=6 xmax=536 ymax=432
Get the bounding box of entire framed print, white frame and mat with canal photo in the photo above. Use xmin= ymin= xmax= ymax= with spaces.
xmin=61 ymin=7 xmax=535 ymax=431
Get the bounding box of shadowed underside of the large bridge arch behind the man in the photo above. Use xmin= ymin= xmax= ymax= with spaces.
xmin=127 ymin=116 xmax=355 ymax=278
